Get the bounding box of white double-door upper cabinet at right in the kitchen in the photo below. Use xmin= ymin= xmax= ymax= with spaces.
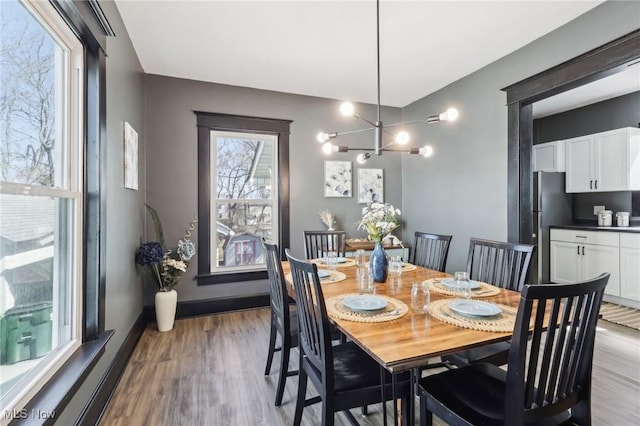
xmin=564 ymin=127 xmax=640 ymax=192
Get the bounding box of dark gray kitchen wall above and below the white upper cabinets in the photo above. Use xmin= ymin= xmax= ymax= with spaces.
xmin=533 ymin=91 xmax=640 ymax=223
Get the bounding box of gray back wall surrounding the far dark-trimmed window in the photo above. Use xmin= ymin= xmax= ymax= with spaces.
xmin=146 ymin=76 xmax=402 ymax=304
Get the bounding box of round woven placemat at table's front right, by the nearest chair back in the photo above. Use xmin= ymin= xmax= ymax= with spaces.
xmin=427 ymin=299 xmax=518 ymax=333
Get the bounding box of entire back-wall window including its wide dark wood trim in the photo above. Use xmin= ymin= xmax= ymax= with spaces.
xmin=197 ymin=113 xmax=290 ymax=284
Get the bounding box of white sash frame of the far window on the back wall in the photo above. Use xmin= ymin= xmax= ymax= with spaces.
xmin=209 ymin=130 xmax=280 ymax=274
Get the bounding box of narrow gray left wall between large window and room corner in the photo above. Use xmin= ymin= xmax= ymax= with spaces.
xmin=56 ymin=2 xmax=145 ymax=425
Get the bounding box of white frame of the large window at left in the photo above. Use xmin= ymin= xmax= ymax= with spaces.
xmin=0 ymin=0 xmax=84 ymax=425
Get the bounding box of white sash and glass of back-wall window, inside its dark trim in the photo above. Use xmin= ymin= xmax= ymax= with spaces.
xmin=211 ymin=130 xmax=279 ymax=273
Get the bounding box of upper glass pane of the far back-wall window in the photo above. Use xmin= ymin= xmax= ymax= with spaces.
xmin=215 ymin=136 xmax=273 ymax=200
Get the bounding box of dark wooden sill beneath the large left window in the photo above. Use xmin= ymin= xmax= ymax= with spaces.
xmin=10 ymin=330 xmax=114 ymax=426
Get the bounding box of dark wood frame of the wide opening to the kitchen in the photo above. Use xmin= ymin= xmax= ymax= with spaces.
xmin=502 ymin=30 xmax=640 ymax=244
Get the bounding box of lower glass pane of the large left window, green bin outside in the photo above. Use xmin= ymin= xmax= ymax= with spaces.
xmin=0 ymin=194 xmax=76 ymax=397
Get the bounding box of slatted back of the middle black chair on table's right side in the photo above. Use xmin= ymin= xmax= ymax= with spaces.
xmin=467 ymin=238 xmax=535 ymax=291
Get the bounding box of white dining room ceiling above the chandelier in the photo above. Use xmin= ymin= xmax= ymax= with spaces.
xmin=116 ymin=0 xmax=620 ymax=108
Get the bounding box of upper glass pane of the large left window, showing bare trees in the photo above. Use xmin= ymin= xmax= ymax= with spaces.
xmin=0 ymin=1 xmax=66 ymax=187
